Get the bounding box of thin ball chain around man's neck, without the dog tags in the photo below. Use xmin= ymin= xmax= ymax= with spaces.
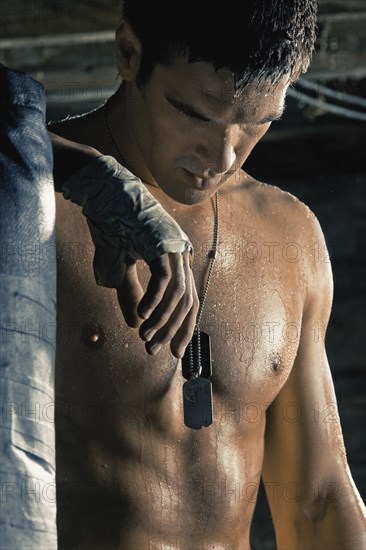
xmin=103 ymin=95 xmax=219 ymax=378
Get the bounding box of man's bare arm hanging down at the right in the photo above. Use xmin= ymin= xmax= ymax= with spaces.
xmin=262 ymin=215 xmax=366 ymax=550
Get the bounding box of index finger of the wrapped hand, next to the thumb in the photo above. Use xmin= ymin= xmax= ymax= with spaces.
xmin=137 ymin=254 xmax=172 ymax=319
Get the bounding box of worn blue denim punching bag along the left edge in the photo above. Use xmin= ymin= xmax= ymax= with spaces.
xmin=0 ymin=65 xmax=57 ymax=550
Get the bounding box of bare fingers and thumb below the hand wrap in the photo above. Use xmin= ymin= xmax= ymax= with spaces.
xmin=117 ymin=252 xmax=199 ymax=357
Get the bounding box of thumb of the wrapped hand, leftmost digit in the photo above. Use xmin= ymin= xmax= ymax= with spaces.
xmin=116 ymin=263 xmax=144 ymax=328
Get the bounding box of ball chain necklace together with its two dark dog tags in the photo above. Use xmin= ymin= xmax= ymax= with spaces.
xmin=103 ymin=100 xmax=219 ymax=429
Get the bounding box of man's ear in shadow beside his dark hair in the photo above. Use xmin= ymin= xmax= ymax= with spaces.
xmin=116 ymin=20 xmax=142 ymax=80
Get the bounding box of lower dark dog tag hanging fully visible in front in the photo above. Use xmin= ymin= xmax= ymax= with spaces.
xmin=183 ymin=377 xmax=212 ymax=430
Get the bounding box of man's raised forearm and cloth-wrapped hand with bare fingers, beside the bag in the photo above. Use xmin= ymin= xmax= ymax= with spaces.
xmin=50 ymin=139 xmax=199 ymax=357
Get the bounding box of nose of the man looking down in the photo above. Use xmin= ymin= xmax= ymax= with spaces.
xmin=196 ymin=128 xmax=236 ymax=174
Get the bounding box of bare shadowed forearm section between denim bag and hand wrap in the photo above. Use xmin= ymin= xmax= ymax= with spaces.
xmin=49 ymin=132 xmax=102 ymax=193
